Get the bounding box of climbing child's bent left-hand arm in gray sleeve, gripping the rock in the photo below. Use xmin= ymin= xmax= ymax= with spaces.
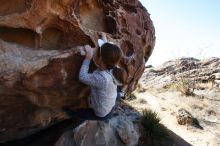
xmin=79 ymin=45 xmax=105 ymax=87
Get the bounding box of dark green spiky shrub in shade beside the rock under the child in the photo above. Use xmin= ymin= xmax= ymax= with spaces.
xmin=140 ymin=110 xmax=172 ymax=146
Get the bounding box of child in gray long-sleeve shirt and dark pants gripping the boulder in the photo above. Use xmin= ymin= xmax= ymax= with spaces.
xmin=64 ymin=33 xmax=127 ymax=120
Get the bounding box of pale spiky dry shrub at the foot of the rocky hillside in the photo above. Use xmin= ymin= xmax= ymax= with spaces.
xmin=174 ymin=76 xmax=195 ymax=96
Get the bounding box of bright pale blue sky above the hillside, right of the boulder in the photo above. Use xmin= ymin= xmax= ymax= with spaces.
xmin=140 ymin=0 xmax=220 ymax=66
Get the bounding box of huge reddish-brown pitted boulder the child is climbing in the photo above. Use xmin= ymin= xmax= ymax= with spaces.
xmin=0 ymin=0 xmax=155 ymax=142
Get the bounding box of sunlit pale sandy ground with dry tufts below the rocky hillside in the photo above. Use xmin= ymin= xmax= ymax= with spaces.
xmin=128 ymin=83 xmax=220 ymax=146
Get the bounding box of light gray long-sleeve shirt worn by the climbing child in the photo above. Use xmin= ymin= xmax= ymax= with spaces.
xmin=79 ymin=59 xmax=118 ymax=117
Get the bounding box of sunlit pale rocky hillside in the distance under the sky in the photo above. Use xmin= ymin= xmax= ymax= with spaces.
xmin=142 ymin=57 xmax=220 ymax=88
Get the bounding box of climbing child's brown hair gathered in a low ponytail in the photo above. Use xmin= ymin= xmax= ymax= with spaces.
xmin=99 ymin=43 xmax=127 ymax=84
